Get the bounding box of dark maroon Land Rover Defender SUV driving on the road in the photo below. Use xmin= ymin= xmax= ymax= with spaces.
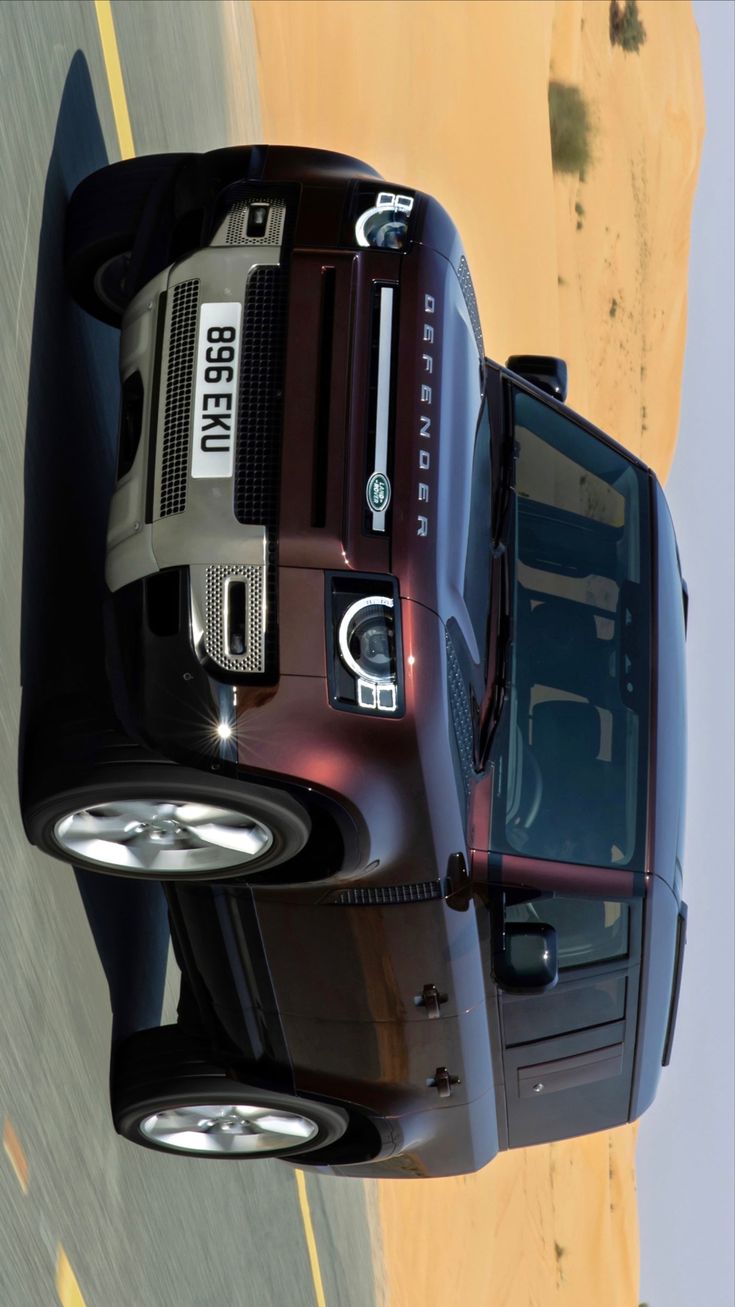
xmin=24 ymin=146 xmax=687 ymax=1176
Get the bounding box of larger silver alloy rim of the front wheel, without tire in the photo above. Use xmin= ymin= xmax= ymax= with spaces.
xmin=54 ymin=799 xmax=273 ymax=880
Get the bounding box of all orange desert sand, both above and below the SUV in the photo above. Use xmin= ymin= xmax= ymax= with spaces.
xmin=252 ymin=0 xmax=704 ymax=1307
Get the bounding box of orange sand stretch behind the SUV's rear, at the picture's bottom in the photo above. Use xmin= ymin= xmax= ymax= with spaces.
xmin=378 ymin=1128 xmax=638 ymax=1307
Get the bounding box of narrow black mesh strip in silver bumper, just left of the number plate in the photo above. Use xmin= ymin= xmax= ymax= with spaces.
xmin=158 ymin=280 xmax=199 ymax=518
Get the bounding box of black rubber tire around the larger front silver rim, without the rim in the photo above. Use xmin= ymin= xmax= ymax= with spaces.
xmin=24 ymin=761 xmax=311 ymax=884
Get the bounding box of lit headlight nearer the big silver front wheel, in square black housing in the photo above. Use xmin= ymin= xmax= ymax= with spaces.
xmin=327 ymin=572 xmax=403 ymax=714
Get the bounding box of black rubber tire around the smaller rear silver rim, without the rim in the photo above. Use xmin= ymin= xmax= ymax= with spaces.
xmin=111 ymin=1026 xmax=349 ymax=1162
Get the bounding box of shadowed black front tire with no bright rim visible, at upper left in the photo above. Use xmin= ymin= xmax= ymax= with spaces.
xmin=64 ymin=154 xmax=187 ymax=327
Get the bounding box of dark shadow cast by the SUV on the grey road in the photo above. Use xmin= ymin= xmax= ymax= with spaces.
xmin=20 ymin=51 xmax=169 ymax=1039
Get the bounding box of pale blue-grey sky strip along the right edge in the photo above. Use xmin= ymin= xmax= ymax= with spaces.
xmin=637 ymin=0 xmax=735 ymax=1307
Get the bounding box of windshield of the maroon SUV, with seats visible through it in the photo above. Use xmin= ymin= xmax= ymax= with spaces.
xmin=490 ymin=391 xmax=650 ymax=869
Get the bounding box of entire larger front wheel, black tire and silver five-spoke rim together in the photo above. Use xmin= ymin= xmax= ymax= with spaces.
xmin=25 ymin=762 xmax=311 ymax=881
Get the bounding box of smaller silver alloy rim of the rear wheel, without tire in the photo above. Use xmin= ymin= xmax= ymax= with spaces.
xmin=140 ymin=1103 xmax=319 ymax=1157
